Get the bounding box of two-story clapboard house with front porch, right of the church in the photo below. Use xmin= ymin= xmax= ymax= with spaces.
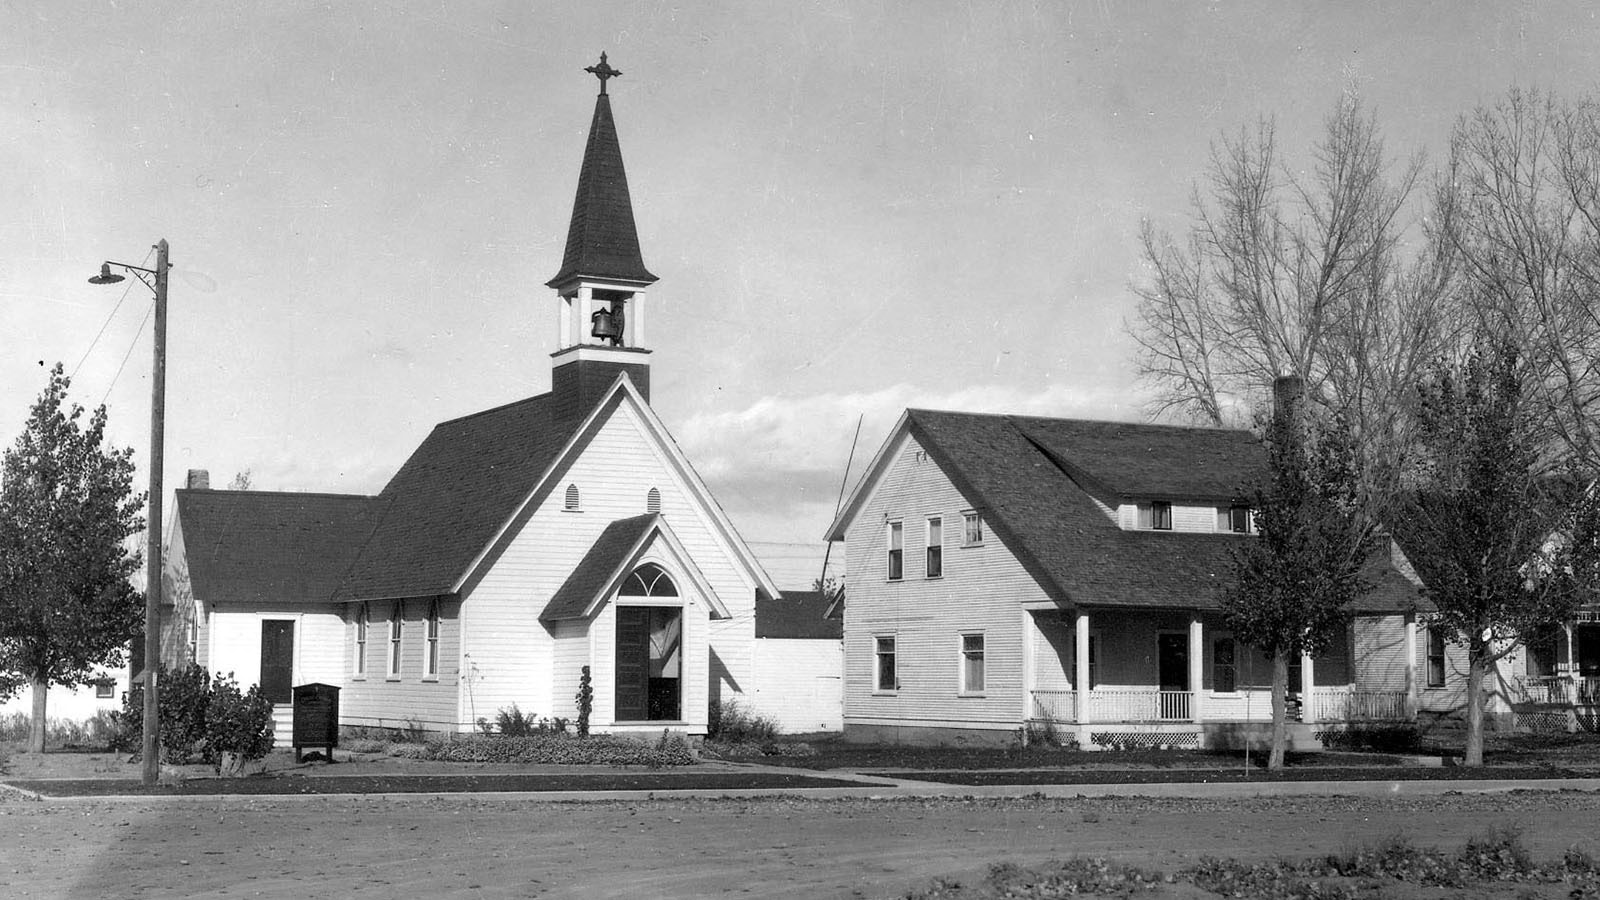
xmin=827 ymin=410 xmax=1424 ymax=748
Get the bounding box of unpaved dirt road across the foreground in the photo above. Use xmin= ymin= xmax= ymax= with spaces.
xmin=0 ymin=791 xmax=1600 ymax=898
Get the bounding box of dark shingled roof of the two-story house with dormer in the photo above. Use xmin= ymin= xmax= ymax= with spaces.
xmin=907 ymin=410 xmax=1416 ymax=612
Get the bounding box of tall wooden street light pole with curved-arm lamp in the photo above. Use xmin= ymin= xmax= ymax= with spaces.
xmin=90 ymin=239 xmax=170 ymax=785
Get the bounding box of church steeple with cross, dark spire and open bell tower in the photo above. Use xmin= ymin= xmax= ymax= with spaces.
xmin=546 ymin=53 xmax=656 ymax=415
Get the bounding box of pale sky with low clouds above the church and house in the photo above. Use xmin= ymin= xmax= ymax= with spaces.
xmin=0 ymin=0 xmax=1600 ymax=543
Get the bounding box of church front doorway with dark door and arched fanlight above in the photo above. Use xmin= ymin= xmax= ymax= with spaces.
xmin=616 ymin=562 xmax=683 ymax=722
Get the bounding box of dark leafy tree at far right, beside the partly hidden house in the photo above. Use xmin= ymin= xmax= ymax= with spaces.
xmin=1392 ymin=341 xmax=1600 ymax=765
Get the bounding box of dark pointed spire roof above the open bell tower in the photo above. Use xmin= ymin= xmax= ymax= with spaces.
xmin=547 ymin=93 xmax=656 ymax=287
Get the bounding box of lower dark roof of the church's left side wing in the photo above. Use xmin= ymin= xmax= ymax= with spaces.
xmin=176 ymin=490 xmax=381 ymax=605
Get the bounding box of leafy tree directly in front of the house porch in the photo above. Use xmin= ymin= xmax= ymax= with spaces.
xmin=1221 ymin=380 xmax=1374 ymax=769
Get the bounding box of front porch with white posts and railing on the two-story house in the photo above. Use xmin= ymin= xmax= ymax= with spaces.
xmin=1024 ymin=609 xmax=1416 ymax=748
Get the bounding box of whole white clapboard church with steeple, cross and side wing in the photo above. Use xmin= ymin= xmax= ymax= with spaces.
xmin=163 ymin=61 xmax=779 ymax=735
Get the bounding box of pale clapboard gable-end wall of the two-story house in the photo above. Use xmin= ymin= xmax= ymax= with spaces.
xmin=845 ymin=434 xmax=1046 ymax=729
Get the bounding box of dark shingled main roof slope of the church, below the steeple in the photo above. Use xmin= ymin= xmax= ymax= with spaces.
xmin=339 ymin=394 xmax=582 ymax=599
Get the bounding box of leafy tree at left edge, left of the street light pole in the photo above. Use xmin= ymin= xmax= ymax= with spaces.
xmin=0 ymin=364 xmax=144 ymax=753
